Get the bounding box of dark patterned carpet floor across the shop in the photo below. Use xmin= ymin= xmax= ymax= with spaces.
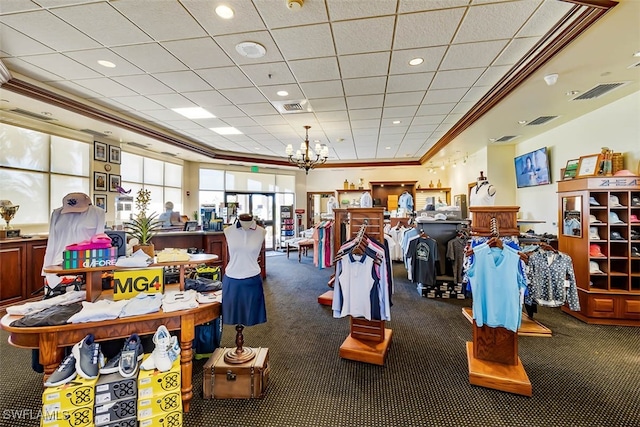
xmin=0 ymin=256 xmax=640 ymax=427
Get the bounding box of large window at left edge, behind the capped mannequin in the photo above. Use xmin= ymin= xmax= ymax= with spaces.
xmin=0 ymin=123 xmax=93 ymax=225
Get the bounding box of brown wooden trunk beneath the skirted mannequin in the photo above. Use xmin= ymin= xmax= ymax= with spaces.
xmin=202 ymin=348 xmax=270 ymax=399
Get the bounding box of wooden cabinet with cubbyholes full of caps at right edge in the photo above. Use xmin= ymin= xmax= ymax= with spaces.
xmin=558 ymin=177 xmax=640 ymax=326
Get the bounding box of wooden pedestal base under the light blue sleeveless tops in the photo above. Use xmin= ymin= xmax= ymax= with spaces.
xmin=467 ymin=322 xmax=532 ymax=397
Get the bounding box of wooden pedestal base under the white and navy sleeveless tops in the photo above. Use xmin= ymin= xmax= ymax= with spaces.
xmin=339 ymin=318 xmax=393 ymax=365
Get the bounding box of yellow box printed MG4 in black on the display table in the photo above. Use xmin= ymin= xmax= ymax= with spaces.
xmin=113 ymin=267 xmax=164 ymax=301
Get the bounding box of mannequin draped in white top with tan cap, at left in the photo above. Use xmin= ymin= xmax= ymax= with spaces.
xmin=42 ymin=193 xmax=105 ymax=298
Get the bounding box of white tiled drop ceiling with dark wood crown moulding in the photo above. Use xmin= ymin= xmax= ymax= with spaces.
xmin=0 ymin=0 xmax=640 ymax=169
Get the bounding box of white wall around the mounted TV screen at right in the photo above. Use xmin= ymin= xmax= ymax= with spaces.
xmin=512 ymin=92 xmax=640 ymax=234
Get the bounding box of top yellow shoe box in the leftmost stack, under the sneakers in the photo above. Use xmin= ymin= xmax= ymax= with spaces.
xmin=42 ymin=376 xmax=98 ymax=413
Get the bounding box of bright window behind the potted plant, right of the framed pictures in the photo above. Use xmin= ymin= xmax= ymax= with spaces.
xmin=120 ymin=152 xmax=181 ymax=214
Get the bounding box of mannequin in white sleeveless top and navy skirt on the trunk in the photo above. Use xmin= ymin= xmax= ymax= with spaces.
xmin=222 ymin=214 xmax=267 ymax=363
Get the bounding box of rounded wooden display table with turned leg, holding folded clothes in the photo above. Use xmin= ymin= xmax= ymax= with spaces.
xmin=0 ymin=291 xmax=221 ymax=412
